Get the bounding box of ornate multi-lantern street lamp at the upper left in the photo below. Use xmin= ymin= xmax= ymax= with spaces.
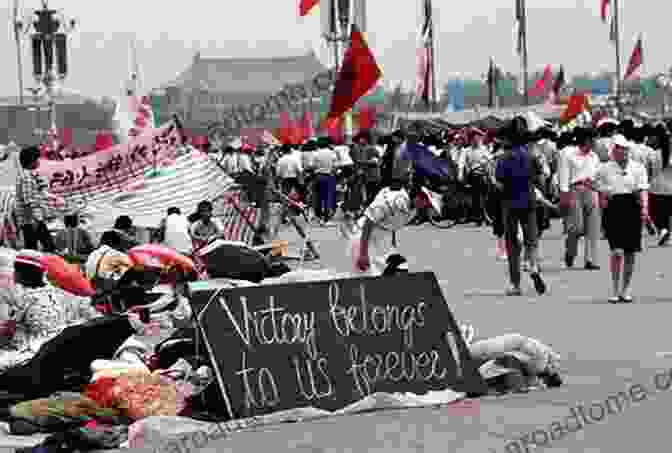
xmin=16 ymin=0 xmax=75 ymax=143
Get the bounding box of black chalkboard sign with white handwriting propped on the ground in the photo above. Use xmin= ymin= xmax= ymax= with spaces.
xmin=191 ymin=272 xmax=484 ymax=418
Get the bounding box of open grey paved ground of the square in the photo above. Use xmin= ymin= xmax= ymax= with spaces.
xmin=203 ymin=221 xmax=672 ymax=453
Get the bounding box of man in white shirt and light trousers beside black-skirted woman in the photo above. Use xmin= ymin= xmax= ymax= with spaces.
xmin=558 ymin=128 xmax=601 ymax=270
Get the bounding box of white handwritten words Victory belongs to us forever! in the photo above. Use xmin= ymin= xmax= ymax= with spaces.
xmin=217 ymin=282 xmax=459 ymax=410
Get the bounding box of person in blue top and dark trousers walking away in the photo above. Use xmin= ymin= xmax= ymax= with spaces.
xmin=495 ymin=117 xmax=546 ymax=296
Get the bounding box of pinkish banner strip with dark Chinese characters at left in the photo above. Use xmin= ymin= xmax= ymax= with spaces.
xmin=38 ymin=122 xmax=181 ymax=195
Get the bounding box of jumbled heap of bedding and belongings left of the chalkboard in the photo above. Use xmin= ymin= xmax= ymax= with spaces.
xmin=0 ymin=249 xmax=212 ymax=451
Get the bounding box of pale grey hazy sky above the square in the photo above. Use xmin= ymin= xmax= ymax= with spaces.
xmin=0 ymin=0 xmax=672 ymax=100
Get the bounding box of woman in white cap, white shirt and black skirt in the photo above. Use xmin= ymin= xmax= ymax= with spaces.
xmin=595 ymin=135 xmax=649 ymax=303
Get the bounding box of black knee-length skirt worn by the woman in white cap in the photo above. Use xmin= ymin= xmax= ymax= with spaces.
xmin=604 ymin=194 xmax=642 ymax=253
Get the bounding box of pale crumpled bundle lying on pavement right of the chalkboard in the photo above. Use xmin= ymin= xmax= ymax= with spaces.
xmin=460 ymin=324 xmax=563 ymax=393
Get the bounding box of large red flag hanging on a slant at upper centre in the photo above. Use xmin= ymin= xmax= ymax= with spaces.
xmin=327 ymin=25 xmax=382 ymax=118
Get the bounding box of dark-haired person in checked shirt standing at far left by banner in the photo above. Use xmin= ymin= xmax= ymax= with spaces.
xmin=15 ymin=146 xmax=56 ymax=253
